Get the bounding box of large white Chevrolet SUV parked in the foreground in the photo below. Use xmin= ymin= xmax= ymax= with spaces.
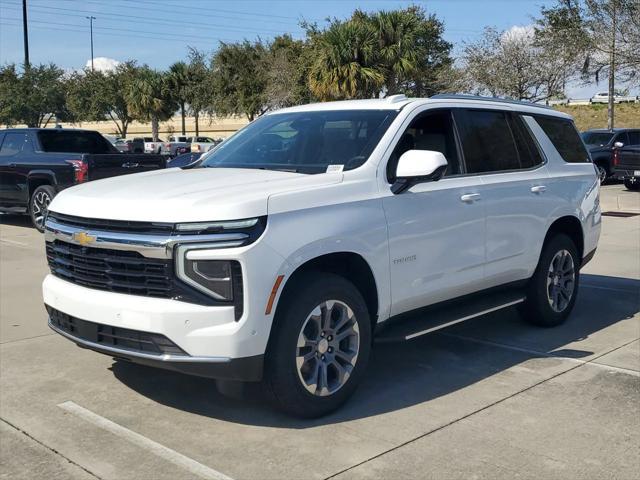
xmin=43 ymin=96 xmax=600 ymax=416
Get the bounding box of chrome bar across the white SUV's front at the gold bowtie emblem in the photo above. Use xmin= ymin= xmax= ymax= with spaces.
xmin=44 ymin=219 xmax=249 ymax=259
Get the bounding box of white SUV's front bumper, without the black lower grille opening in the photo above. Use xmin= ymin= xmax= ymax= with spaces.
xmin=42 ymin=274 xmax=272 ymax=381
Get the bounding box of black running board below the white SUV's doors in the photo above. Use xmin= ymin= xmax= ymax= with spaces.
xmin=375 ymin=290 xmax=526 ymax=343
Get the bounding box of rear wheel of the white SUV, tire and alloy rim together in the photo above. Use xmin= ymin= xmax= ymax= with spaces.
xmin=520 ymin=234 xmax=581 ymax=327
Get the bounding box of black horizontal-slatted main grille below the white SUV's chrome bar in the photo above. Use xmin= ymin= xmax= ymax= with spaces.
xmin=46 ymin=240 xmax=175 ymax=298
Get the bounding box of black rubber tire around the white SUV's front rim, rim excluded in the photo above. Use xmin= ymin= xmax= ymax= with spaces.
xmin=265 ymin=273 xmax=371 ymax=417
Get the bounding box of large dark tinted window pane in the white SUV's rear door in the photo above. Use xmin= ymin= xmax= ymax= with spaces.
xmin=456 ymin=110 xmax=520 ymax=173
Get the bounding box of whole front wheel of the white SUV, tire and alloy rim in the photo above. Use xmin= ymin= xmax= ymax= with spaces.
xmin=265 ymin=272 xmax=371 ymax=418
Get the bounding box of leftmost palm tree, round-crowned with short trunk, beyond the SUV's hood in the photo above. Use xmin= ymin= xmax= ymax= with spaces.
xmin=127 ymin=66 xmax=177 ymax=142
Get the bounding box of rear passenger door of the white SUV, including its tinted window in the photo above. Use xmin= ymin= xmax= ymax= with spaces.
xmin=455 ymin=109 xmax=550 ymax=288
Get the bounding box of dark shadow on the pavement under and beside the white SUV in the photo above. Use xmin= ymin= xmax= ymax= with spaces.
xmin=107 ymin=274 xmax=640 ymax=428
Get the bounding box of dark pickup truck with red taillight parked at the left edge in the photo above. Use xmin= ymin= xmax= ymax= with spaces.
xmin=0 ymin=128 xmax=167 ymax=231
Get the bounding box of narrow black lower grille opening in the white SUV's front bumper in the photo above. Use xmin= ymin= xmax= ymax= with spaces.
xmin=46 ymin=305 xmax=188 ymax=356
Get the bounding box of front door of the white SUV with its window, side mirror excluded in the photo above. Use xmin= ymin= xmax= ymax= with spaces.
xmin=383 ymin=110 xmax=485 ymax=315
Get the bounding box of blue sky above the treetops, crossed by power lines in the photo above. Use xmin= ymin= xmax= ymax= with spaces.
xmin=0 ymin=0 xmax=624 ymax=95
